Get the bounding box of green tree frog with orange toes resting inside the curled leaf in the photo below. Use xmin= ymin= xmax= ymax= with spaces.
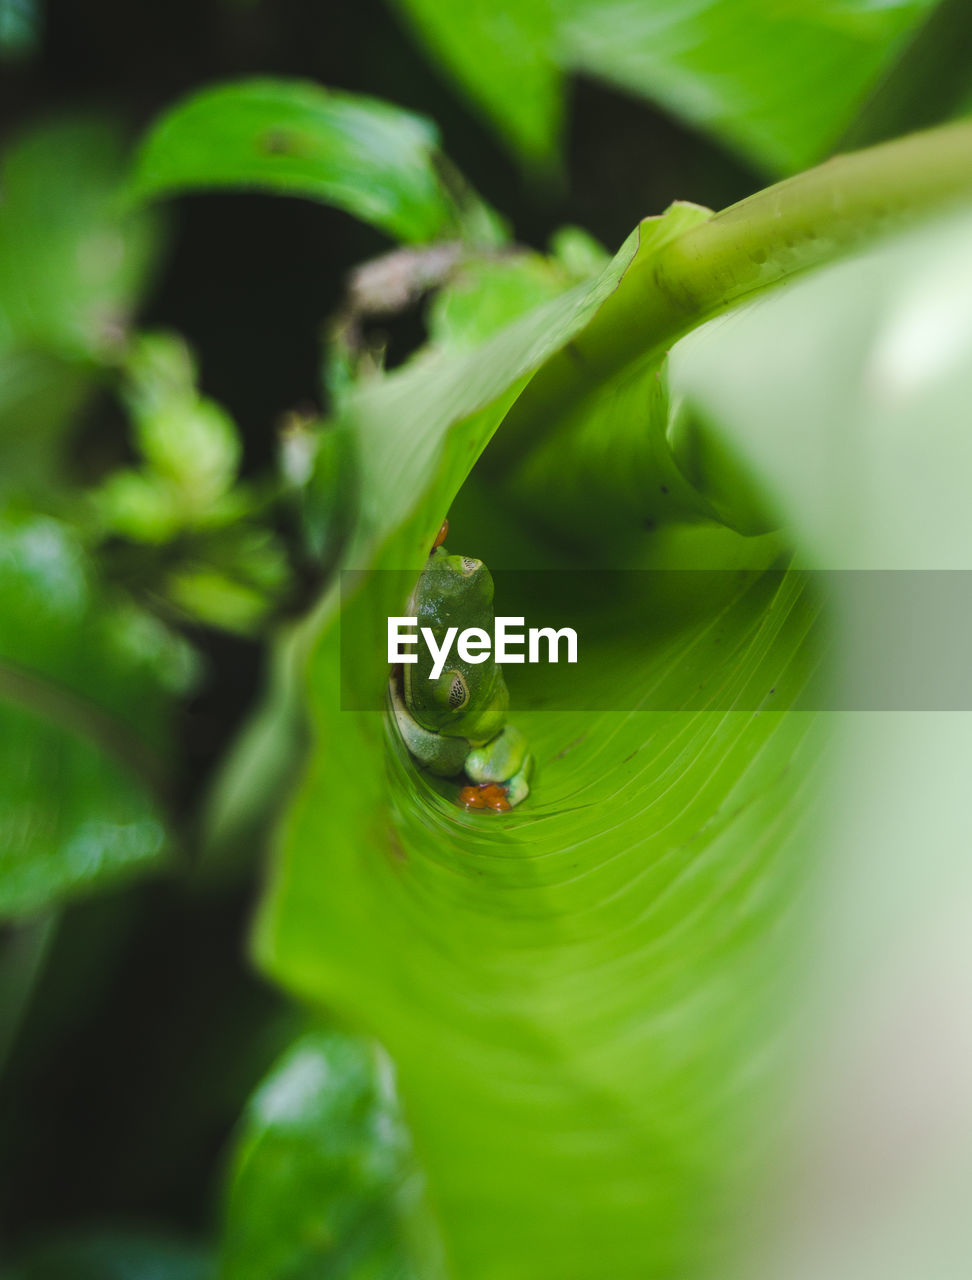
xmin=389 ymin=535 xmax=533 ymax=810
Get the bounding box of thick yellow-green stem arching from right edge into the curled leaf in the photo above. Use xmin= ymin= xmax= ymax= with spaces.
xmin=497 ymin=122 xmax=972 ymax=460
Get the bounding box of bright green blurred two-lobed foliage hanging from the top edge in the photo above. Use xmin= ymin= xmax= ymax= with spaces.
xmin=397 ymin=0 xmax=932 ymax=174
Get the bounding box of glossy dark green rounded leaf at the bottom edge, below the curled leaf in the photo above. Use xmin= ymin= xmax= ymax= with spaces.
xmin=220 ymin=1032 xmax=425 ymax=1280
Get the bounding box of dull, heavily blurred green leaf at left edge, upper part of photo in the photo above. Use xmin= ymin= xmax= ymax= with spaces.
xmin=0 ymin=120 xmax=158 ymax=493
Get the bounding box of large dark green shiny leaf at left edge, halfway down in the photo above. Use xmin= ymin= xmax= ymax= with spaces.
xmin=0 ymin=516 xmax=192 ymax=916
